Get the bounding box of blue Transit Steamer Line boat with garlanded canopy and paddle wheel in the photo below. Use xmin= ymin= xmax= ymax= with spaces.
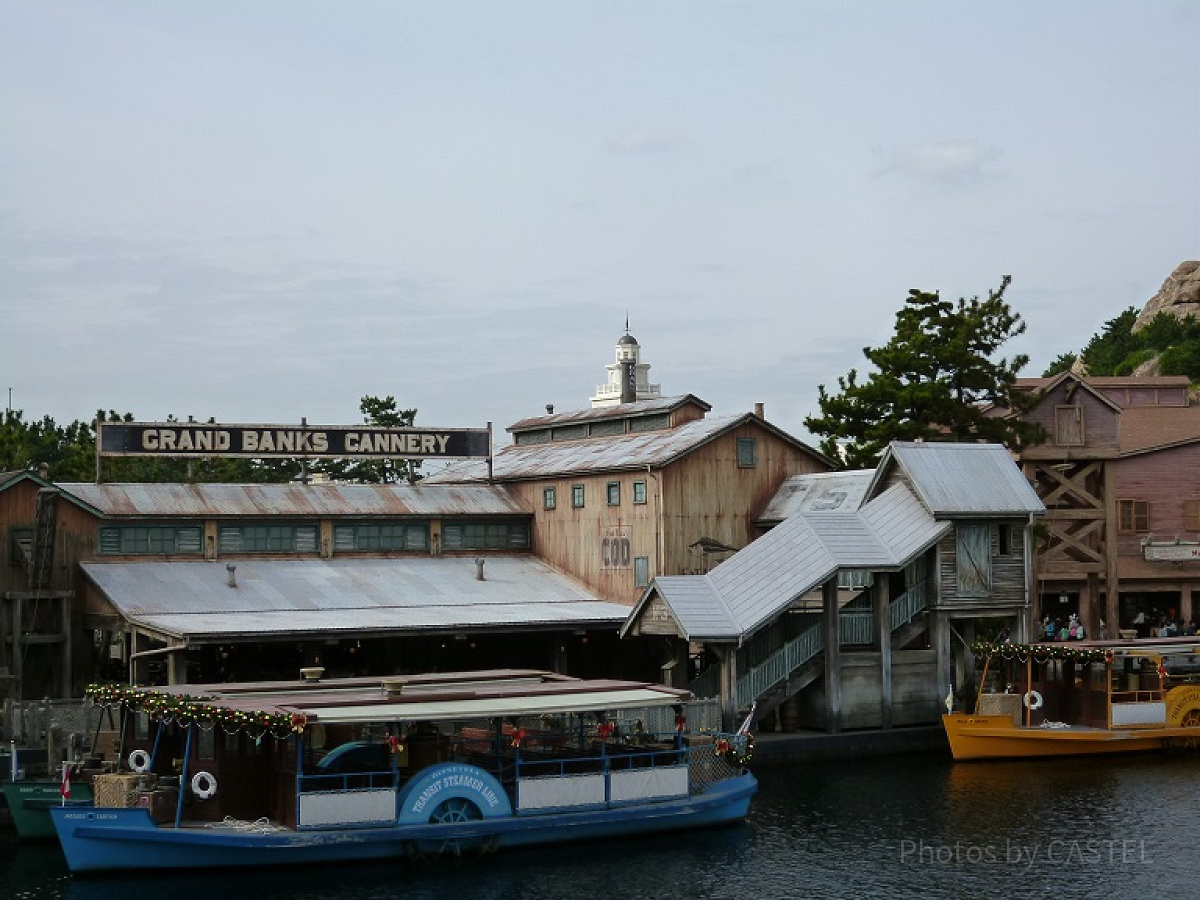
xmin=49 ymin=670 xmax=757 ymax=872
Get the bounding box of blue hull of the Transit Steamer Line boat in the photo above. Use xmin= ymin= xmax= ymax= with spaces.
xmin=49 ymin=774 xmax=757 ymax=872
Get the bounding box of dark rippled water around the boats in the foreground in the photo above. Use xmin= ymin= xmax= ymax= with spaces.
xmin=0 ymin=755 xmax=1200 ymax=900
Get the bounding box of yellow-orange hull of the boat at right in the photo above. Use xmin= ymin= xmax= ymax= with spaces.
xmin=942 ymin=713 xmax=1180 ymax=760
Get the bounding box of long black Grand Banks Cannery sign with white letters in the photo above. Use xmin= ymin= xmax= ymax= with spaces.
xmin=96 ymin=422 xmax=492 ymax=460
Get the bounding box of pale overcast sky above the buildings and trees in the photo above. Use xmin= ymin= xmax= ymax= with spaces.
xmin=0 ymin=0 xmax=1200 ymax=444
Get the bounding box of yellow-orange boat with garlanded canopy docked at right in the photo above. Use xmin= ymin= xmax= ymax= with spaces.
xmin=942 ymin=637 xmax=1200 ymax=760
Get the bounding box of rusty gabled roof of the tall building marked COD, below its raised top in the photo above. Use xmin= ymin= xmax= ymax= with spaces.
xmin=422 ymin=413 xmax=827 ymax=484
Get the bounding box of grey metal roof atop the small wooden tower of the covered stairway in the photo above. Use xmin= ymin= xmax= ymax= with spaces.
xmin=872 ymin=440 xmax=1045 ymax=517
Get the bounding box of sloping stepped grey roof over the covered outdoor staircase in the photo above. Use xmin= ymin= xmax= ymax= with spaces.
xmin=623 ymin=485 xmax=953 ymax=642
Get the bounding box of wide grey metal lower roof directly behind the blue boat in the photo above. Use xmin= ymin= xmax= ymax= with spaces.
xmin=80 ymin=556 xmax=629 ymax=640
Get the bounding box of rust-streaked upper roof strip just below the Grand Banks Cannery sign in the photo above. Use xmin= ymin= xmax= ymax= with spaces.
xmin=59 ymin=481 xmax=529 ymax=517
